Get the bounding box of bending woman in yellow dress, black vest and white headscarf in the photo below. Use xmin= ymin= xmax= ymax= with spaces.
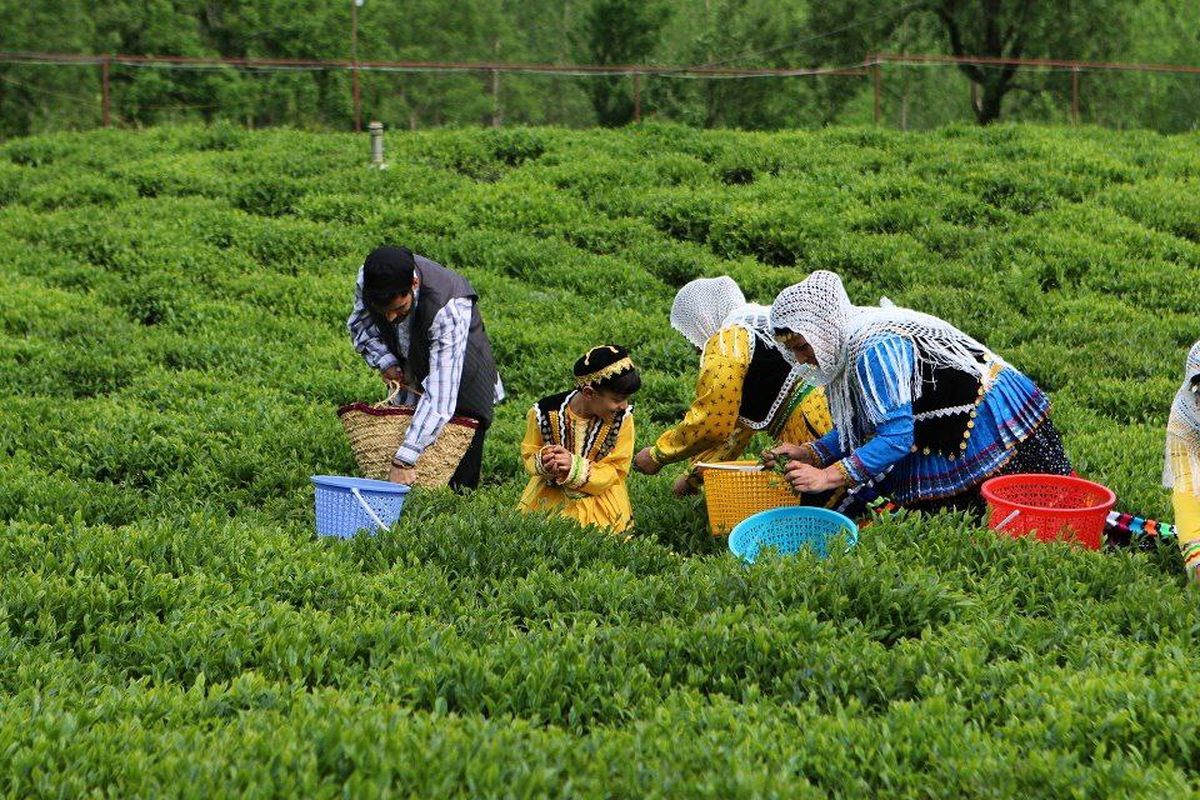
xmin=635 ymin=277 xmax=833 ymax=495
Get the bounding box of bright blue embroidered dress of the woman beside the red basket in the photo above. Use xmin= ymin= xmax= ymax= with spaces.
xmin=812 ymin=333 xmax=1050 ymax=505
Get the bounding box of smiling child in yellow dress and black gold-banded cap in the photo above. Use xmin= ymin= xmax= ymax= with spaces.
xmin=517 ymin=344 xmax=642 ymax=533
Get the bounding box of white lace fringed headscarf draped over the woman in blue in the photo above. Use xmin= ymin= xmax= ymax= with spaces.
xmin=770 ymin=270 xmax=994 ymax=451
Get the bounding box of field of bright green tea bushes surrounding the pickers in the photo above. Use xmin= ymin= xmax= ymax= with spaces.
xmin=0 ymin=125 xmax=1200 ymax=798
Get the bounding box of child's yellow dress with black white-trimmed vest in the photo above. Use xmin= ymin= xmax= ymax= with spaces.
xmin=517 ymin=391 xmax=634 ymax=533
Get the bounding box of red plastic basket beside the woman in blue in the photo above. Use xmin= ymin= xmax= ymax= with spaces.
xmin=982 ymin=475 xmax=1117 ymax=551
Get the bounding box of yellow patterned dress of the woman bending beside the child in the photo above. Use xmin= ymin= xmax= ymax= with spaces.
xmin=652 ymin=325 xmax=833 ymax=483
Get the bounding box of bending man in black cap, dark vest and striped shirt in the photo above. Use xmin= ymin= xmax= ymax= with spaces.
xmin=346 ymin=246 xmax=504 ymax=489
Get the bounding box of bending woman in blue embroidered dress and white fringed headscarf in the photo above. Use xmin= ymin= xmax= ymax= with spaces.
xmin=770 ymin=270 xmax=1072 ymax=511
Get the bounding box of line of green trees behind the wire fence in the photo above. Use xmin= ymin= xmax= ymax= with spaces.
xmin=0 ymin=0 xmax=1200 ymax=137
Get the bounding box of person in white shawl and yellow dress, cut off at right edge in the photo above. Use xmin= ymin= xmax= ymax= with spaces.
xmin=1163 ymin=342 xmax=1200 ymax=584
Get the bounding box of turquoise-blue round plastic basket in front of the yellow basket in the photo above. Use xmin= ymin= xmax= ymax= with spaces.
xmin=730 ymin=506 xmax=858 ymax=564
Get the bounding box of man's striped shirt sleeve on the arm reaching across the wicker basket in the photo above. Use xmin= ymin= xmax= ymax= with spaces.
xmin=396 ymin=297 xmax=472 ymax=464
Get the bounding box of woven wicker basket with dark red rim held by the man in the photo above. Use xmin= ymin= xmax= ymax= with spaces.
xmin=337 ymin=389 xmax=479 ymax=488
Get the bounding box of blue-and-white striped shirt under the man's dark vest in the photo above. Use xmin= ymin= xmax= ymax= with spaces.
xmin=346 ymin=269 xmax=504 ymax=464
